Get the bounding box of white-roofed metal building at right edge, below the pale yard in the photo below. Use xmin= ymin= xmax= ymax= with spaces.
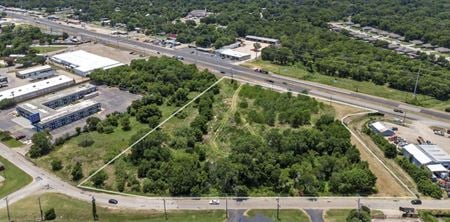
xmin=403 ymin=144 xmax=450 ymax=169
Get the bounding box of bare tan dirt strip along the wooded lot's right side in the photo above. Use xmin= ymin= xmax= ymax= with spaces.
xmin=349 ymin=114 xmax=416 ymax=197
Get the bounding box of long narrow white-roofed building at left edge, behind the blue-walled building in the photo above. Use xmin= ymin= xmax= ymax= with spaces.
xmin=0 ymin=75 xmax=75 ymax=102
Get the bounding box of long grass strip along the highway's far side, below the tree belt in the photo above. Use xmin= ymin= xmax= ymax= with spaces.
xmin=243 ymin=60 xmax=450 ymax=110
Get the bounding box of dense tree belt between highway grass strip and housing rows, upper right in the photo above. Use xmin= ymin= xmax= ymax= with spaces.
xmin=261 ymin=24 xmax=450 ymax=100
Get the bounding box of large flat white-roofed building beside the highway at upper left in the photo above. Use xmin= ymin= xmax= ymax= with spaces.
xmin=50 ymin=50 xmax=123 ymax=76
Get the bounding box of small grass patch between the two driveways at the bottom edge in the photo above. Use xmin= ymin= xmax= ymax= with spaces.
xmin=247 ymin=210 xmax=310 ymax=222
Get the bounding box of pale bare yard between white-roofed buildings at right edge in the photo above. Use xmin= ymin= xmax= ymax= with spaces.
xmin=382 ymin=119 xmax=450 ymax=153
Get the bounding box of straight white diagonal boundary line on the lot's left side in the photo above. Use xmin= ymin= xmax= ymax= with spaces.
xmin=77 ymin=77 xmax=224 ymax=187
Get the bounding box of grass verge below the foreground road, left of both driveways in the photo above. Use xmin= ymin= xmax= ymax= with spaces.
xmin=0 ymin=193 xmax=225 ymax=222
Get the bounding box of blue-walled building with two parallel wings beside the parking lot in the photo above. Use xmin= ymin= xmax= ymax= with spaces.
xmin=16 ymin=84 xmax=101 ymax=131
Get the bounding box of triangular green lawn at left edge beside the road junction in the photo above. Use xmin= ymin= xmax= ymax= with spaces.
xmin=0 ymin=154 xmax=32 ymax=198
